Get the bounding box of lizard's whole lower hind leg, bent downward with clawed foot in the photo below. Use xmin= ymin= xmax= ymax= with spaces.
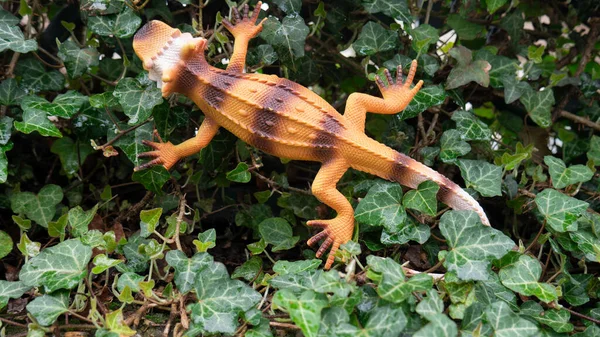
xmin=306 ymin=158 xmax=354 ymax=269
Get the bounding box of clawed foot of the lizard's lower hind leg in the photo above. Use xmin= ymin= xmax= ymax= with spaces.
xmin=306 ymin=217 xmax=354 ymax=269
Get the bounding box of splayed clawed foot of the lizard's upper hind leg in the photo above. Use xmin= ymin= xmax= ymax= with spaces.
xmin=375 ymin=60 xmax=423 ymax=103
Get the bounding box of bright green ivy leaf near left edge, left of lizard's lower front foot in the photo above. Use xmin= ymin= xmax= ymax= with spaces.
xmin=15 ymin=96 xmax=62 ymax=137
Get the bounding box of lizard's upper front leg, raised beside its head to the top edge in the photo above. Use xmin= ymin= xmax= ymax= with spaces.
xmin=222 ymin=1 xmax=266 ymax=73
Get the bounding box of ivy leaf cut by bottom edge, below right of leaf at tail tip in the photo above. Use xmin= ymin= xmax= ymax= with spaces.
xmin=484 ymin=302 xmax=538 ymax=337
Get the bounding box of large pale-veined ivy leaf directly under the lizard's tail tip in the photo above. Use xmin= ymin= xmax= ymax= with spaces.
xmin=440 ymin=211 xmax=515 ymax=281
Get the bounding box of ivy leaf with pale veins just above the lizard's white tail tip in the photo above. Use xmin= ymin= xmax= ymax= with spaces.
xmin=457 ymin=159 xmax=502 ymax=197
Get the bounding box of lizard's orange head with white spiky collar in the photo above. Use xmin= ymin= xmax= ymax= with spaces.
xmin=133 ymin=20 xmax=206 ymax=95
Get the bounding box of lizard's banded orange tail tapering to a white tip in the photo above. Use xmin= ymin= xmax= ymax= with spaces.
xmin=348 ymin=137 xmax=490 ymax=226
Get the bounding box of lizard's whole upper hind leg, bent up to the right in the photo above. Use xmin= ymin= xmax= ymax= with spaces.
xmin=344 ymin=60 xmax=423 ymax=131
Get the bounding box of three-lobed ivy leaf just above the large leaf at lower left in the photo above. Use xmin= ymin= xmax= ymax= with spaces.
xmin=165 ymin=250 xmax=213 ymax=294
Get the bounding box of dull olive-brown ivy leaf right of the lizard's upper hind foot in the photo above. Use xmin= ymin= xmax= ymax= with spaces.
xmin=446 ymin=46 xmax=492 ymax=90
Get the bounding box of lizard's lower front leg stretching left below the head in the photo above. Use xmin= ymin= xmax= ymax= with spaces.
xmin=133 ymin=117 xmax=219 ymax=171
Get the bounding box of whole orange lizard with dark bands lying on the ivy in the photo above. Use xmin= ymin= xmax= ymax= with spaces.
xmin=133 ymin=3 xmax=489 ymax=269
